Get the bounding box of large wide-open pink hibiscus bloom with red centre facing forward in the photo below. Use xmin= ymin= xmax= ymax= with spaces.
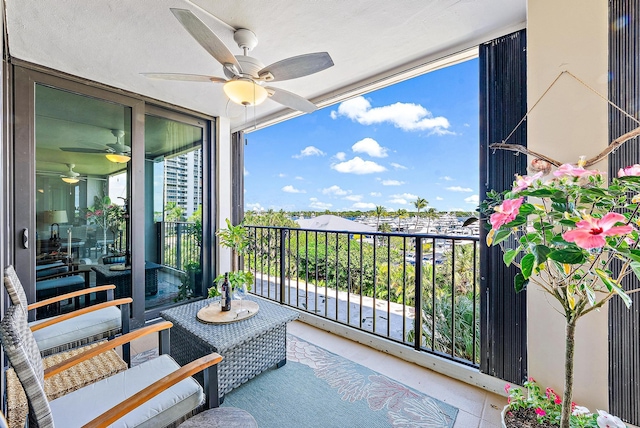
xmin=562 ymin=213 xmax=633 ymax=249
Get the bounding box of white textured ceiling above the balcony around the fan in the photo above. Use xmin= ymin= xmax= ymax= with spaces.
xmin=6 ymin=0 xmax=526 ymax=130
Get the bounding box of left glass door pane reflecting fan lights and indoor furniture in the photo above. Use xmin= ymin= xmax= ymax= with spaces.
xmin=34 ymin=84 xmax=132 ymax=300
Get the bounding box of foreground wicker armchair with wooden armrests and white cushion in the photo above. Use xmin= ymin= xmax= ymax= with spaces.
xmin=0 ymin=306 xmax=222 ymax=427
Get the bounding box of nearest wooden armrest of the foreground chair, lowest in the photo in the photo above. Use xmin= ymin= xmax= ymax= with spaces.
xmin=83 ymin=353 xmax=222 ymax=428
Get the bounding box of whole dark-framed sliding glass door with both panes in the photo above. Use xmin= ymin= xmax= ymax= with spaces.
xmin=13 ymin=67 xmax=214 ymax=326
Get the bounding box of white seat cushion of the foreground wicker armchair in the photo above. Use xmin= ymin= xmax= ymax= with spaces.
xmin=49 ymin=355 xmax=204 ymax=428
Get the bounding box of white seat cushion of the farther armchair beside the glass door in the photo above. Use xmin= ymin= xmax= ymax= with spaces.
xmin=29 ymin=307 xmax=122 ymax=355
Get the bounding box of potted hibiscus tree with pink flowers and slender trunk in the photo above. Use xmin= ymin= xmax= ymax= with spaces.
xmin=481 ymin=159 xmax=640 ymax=428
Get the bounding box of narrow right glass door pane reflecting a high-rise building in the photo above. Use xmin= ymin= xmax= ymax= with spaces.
xmin=145 ymin=114 xmax=204 ymax=309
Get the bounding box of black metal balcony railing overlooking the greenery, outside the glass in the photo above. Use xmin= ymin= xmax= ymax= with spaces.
xmin=244 ymin=226 xmax=480 ymax=366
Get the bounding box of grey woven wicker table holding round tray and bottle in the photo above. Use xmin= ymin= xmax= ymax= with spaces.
xmin=160 ymin=296 xmax=298 ymax=407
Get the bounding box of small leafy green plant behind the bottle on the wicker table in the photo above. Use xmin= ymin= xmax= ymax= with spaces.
xmin=208 ymin=218 xmax=253 ymax=297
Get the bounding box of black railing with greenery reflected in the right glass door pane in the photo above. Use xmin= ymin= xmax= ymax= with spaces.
xmin=156 ymin=221 xmax=201 ymax=270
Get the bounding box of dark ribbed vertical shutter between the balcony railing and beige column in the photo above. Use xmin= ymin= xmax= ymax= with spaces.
xmin=479 ymin=30 xmax=527 ymax=383
